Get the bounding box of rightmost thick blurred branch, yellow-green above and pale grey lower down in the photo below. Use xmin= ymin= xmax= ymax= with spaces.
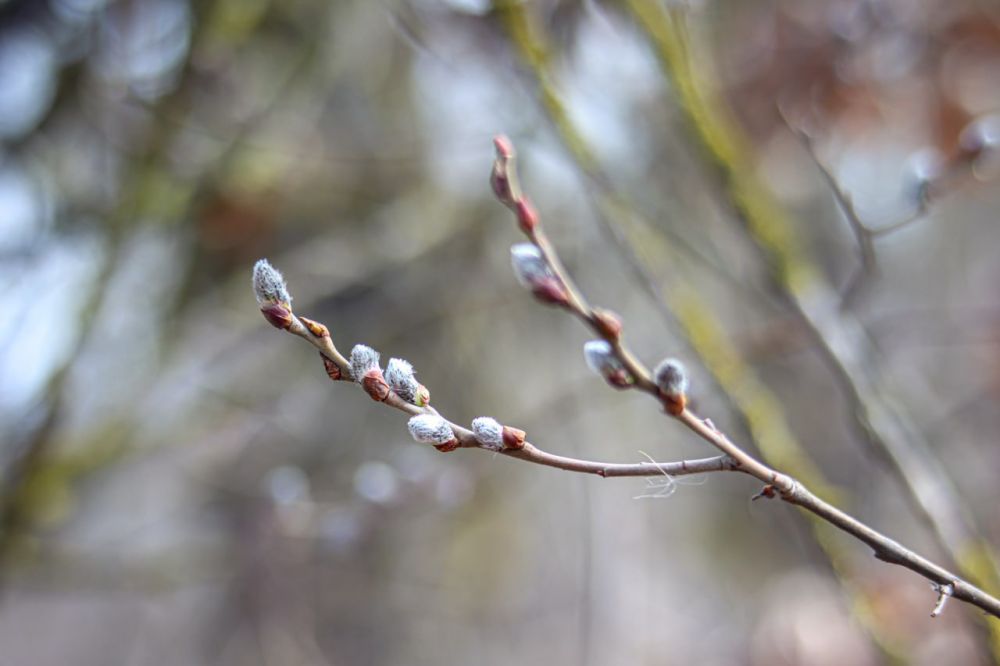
xmin=627 ymin=0 xmax=1000 ymax=656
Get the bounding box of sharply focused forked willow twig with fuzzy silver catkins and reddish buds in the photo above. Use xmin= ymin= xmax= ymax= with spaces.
xmin=254 ymin=137 xmax=1000 ymax=617
